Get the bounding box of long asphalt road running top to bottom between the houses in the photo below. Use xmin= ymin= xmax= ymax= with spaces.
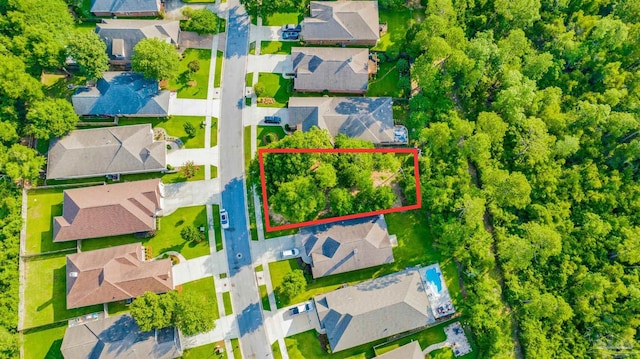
xmin=218 ymin=0 xmax=273 ymax=359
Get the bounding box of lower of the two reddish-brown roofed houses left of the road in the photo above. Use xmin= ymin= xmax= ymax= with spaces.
xmin=67 ymin=243 xmax=173 ymax=309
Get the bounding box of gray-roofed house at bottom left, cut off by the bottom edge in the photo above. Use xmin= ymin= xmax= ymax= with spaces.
xmin=60 ymin=314 xmax=182 ymax=359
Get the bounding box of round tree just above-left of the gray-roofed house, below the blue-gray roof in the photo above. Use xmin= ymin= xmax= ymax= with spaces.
xmin=26 ymin=98 xmax=78 ymax=140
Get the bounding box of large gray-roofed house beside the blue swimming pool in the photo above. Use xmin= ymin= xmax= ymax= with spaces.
xmin=313 ymin=269 xmax=435 ymax=353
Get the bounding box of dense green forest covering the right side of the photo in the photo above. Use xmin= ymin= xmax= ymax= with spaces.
xmin=406 ymin=0 xmax=640 ymax=358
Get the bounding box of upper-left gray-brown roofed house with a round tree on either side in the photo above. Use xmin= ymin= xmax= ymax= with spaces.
xmin=96 ymin=19 xmax=180 ymax=65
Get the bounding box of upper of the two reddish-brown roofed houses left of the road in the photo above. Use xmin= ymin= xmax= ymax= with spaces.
xmin=53 ymin=179 xmax=162 ymax=242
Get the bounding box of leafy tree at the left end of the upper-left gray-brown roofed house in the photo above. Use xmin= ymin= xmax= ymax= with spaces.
xmin=67 ymin=31 xmax=109 ymax=79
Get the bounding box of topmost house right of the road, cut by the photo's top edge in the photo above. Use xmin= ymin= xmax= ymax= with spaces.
xmin=300 ymin=1 xmax=380 ymax=46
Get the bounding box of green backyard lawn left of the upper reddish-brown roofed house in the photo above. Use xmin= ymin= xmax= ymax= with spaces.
xmin=25 ymin=189 xmax=76 ymax=254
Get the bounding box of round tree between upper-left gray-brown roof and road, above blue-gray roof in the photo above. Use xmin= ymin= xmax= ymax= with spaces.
xmin=131 ymin=38 xmax=180 ymax=80
